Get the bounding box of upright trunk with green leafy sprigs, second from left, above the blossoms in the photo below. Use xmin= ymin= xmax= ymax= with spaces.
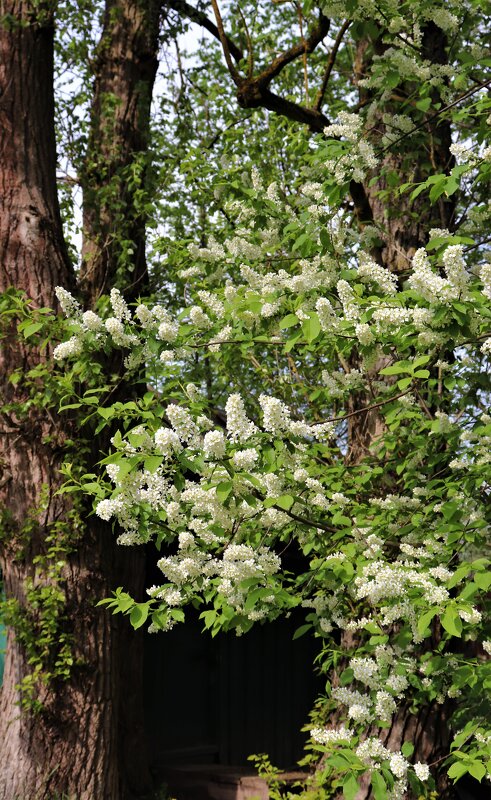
xmin=80 ymin=0 xmax=160 ymax=304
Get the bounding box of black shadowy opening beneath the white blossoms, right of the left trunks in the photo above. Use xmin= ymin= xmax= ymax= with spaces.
xmin=145 ymin=615 xmax=321 ymax=770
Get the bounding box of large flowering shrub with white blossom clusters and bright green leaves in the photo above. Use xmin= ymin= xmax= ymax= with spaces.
xmin=54 ymin=2 xmax=491 ymax=800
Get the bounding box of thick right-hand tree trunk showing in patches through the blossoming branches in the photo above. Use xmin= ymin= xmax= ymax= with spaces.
xmin=347 ymin=22 xmax=455 ymax=800
